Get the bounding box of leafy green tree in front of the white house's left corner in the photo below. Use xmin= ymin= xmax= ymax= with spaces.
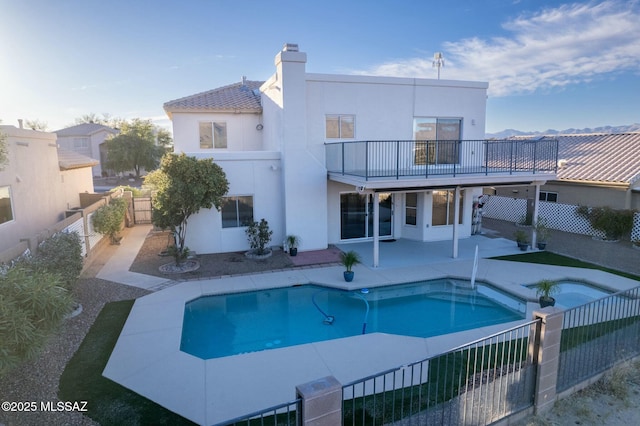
xmin=144 ymin=153 xmax=229 ymax=263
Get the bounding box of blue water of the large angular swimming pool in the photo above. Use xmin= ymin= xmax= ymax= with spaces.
xmin=180 ymin=280 xmax=526 ymax=359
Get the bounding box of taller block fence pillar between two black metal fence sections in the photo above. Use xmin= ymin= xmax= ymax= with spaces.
xmin=533 ymin=307 xmax=563 ymax=414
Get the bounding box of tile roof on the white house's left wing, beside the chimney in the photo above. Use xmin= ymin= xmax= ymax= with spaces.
xmin=164 ymin=80 xmax=264 ymax=113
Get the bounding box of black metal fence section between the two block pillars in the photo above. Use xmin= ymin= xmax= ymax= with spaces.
xmin=342 ymin=320 xmax=539 ymax=425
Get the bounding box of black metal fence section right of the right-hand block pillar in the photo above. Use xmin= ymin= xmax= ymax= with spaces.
xmin=556 ymin=287 xmax=640 ymax=392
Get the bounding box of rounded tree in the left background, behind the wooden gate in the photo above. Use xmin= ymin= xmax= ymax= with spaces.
xmin=105 ymin=118 xmax=171 ymax=177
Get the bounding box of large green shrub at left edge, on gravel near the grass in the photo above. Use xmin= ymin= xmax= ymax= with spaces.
xmin=0 ymin=265 xmax=73 ymax=376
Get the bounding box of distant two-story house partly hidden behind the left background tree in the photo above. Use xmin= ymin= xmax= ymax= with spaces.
xmin=53 ymin=123 xmax=118 ymax=177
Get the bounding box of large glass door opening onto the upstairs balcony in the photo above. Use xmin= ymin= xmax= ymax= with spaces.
xmin=413 ymin=117 xmax=462 ymax=165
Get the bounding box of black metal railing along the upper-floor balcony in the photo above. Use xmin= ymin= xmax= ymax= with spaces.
xmin=325 ymin=138 xmax=558 ymax=180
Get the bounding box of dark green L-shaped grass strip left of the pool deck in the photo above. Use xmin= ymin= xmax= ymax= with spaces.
xmin=58 ymin=300 xmax=194 ymax=425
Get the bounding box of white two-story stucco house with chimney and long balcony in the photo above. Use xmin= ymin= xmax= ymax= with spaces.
xmin=164 ymin=44 xmax=557 ymax=265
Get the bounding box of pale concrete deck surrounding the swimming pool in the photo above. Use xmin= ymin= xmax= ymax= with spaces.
xmin=103 ymin=259 xmax=638 ymax=425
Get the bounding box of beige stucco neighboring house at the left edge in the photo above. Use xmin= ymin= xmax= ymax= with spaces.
xmin=0 ymin=126 xmax=97 ymax=255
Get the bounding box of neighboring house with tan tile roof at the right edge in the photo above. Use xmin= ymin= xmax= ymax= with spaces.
xmin=495 ymin=132 xmax=640 ymax=210
